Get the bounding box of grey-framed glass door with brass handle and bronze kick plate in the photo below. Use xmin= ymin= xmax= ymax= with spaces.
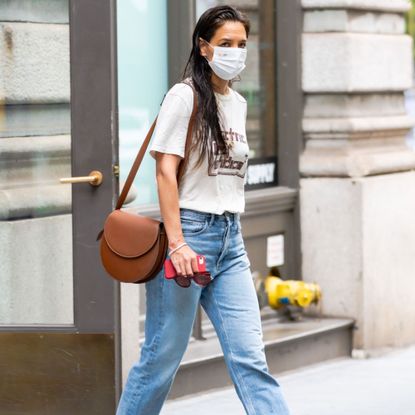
xmin=0 ymin=0 xmax=120 ymax=415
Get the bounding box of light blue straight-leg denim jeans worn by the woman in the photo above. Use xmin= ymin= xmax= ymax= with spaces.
xmin=117 ymin=209 xmax=289 ymax=415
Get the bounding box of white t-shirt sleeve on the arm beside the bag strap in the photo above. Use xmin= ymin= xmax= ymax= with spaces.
xmin=150 ymin=83 xmax=193 ymax=158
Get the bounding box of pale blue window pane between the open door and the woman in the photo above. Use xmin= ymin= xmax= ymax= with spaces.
xmin=117 ymin=0 xmax=168 ymax=207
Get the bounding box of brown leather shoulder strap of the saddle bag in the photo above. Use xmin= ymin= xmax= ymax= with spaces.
xmin=115 ymin=81 xmax=197 ymax=209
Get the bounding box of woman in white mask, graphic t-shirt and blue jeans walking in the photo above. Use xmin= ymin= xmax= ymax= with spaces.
xmin=117 ymin=6 xmax=289 ymax=415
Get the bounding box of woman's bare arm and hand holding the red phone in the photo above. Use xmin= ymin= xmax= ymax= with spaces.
xmin=156 ymin=152 xmax=202 ymax=275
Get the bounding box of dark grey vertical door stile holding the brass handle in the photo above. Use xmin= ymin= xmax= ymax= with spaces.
xmin=70 ymin=0 xmax=122 ymax=401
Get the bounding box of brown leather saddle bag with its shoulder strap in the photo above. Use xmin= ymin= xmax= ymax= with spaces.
xmin=97 ymin=85 xmax=197 ymax=284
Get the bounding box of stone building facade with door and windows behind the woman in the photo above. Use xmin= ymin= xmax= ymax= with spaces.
xmin=0 ymin=0 xmax=415 ymax=414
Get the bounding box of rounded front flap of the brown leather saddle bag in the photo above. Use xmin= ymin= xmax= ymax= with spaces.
xmin=104 ymin=209 xmax=160 ymax=258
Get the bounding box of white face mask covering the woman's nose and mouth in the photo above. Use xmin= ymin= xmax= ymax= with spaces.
xmin=205 ymin=40 xmax=247 ymax=81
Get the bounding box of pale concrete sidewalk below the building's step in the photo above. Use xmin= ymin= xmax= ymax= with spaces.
xmin=161 ymin=346 xmax=415 ymax=415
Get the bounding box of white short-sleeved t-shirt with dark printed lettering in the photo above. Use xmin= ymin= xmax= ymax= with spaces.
xmin=150 ymin=83 xmax=249 ymax=214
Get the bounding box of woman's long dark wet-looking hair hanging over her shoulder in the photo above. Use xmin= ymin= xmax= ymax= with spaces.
xmin=183 ymin=6 xmax=250 ymax=168
